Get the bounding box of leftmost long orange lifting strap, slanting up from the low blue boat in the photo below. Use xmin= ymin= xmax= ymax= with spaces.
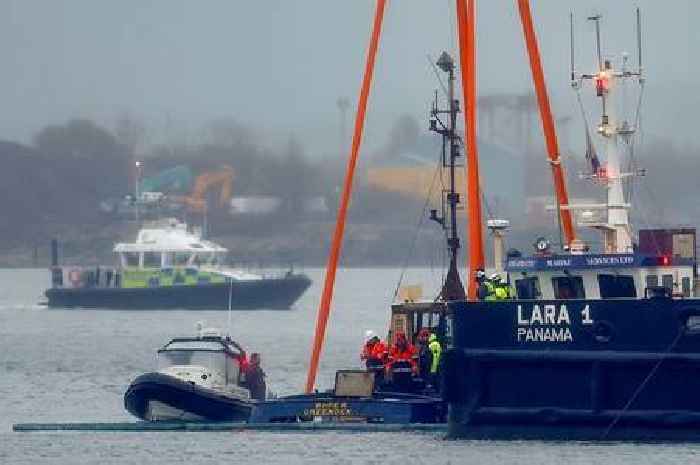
xmin=306 ymin=0 xmax=386 ymax=393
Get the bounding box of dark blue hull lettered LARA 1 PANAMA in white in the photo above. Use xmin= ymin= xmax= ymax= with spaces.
xmin=443 ymin=299 xmax=700 ymax=440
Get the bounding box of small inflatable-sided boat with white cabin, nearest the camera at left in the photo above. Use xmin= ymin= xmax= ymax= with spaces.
xmin=124 ymin=326 xmax=266 ymax=421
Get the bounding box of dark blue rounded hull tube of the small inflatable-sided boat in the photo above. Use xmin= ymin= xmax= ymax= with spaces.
xmin=124 ymin=373 xmax=254 ymax=422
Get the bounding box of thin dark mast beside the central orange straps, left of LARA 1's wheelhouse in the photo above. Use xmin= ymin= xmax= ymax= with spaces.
xmin=430 ymin=52 xmax=465 ymax=300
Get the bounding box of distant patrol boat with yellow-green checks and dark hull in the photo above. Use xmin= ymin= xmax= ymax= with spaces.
xmin=46 ymin=218 xmax=311 ymax=310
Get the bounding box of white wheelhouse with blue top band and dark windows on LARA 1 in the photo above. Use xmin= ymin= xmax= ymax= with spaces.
xmin=505 ymin=253 xmax=696 ymax=300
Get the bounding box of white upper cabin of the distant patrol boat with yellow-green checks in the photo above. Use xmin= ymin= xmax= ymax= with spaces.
xmin=114 ymin=218 xmax=228 ymax=269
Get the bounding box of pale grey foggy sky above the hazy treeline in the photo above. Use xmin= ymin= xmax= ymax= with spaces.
xmin=0 ymin=0 xmax=700 ymax=153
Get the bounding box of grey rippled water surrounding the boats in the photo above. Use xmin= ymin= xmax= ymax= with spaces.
xmin=0 ymin=269 xmax=700 ymax=465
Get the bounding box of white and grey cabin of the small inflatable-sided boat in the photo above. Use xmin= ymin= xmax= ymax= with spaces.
xmin=157 ymin=335 xmax=248 ymax=394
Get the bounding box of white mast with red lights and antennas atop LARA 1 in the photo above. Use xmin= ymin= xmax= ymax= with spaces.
xmin=571 ymin=9 xmax=644 ymax=253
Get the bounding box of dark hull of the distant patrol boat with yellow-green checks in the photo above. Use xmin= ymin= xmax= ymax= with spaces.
xmin=46 ymin=275 xmax=311 ymax=310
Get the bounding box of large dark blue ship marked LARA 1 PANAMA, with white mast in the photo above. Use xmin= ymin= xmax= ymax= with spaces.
xmin=443 ymin=11 xmax=700 ymax=441
